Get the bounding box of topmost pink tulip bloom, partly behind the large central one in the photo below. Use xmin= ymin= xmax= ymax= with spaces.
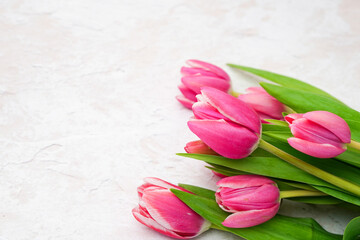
xmin=176 ymin=60 xmax=230 ymax=109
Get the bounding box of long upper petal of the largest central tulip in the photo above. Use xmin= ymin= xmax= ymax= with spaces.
xmin=201 ymin=87 xmax=261 ymax=134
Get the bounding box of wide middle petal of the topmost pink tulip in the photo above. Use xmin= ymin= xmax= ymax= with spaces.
xmin=181 ymin=76 xmax=230 ymax=93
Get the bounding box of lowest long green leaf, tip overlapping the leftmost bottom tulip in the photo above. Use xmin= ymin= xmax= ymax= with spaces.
xmin=171 ymin=189 xmax=342 ymax=240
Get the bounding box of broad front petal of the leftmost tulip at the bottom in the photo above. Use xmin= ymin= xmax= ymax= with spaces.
xmin=142 ymin=189 xmax=205 ymax=235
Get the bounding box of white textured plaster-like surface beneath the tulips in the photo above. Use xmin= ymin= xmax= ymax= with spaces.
xmin=0 ymin=0 xmax=360 ymax=240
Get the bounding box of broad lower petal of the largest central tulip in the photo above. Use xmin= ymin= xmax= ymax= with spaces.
xmin=188 ymin=119 xmax=259 ymax=159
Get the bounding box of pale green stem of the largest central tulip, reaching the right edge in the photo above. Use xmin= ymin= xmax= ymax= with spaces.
xmin=259 ymin=139 xmax=360 ymax=197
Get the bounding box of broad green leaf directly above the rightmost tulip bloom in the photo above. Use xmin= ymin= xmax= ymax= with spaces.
xmin=260 ymin=82 xmax=360 ymax=141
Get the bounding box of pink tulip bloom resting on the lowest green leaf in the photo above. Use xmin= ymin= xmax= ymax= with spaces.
xmin=215 ymin=175 xmax=280 ymax=228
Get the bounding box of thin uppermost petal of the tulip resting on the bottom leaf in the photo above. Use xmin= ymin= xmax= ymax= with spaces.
xmin=216 ymin=175 xmax=275 ymax=188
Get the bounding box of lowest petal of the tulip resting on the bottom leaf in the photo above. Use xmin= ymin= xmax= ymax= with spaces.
xmin=222 ymin=204 xmax=280 ymax=228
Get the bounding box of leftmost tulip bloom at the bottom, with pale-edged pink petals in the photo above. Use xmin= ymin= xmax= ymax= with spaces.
xmin=132 ymin=178 xmax=211 ymax=239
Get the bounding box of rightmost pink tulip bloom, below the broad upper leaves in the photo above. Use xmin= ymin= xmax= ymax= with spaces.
xmin=285 ymin=111 xmax=351 ymax=158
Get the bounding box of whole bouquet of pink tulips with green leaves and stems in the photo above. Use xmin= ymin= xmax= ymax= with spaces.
xmin=133 ymin=60 xmax=360 ymax=240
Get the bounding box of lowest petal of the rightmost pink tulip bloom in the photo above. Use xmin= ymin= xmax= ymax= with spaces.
xmin=288 ymin=137 xmax=346 ymax=158
